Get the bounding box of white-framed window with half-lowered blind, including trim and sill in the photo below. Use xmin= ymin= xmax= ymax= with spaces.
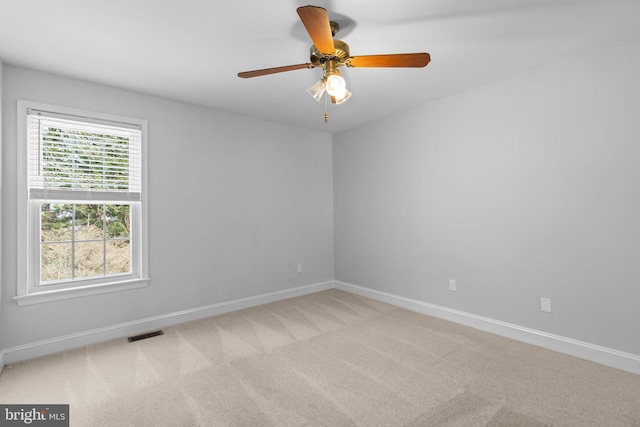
xmin=15 ymin=101 xmax=148 ymax=305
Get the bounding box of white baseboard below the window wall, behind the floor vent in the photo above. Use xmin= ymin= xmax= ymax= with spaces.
xmin=0 ymin=281 xmax=334 ymax=371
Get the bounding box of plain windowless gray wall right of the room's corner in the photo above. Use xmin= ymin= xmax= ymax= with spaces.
xmin=333 ymin=37 xmax=640 ymax=354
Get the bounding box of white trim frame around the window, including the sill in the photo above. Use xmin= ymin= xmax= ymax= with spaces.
xmin=13 ymin=100 xmax=150 ymax=305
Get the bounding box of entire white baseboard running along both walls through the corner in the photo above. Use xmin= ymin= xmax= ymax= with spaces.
xmin=0 ymin=281 xmax=640 ymax=375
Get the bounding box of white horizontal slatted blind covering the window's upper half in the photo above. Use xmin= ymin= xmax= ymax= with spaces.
xmin=27 ymin=109 xmax=141 ymax=202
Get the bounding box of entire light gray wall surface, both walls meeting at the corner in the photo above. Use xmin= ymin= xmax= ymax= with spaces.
xmin=0 ymin=35 xmax=640 ymax=362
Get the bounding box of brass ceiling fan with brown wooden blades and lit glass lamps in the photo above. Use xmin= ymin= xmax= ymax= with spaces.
xmin=238 ymin=6 xmax=431 ymax=121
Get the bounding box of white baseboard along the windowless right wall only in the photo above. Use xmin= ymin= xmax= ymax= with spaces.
xmin=335 ymin=281 xmax=640 ymax=375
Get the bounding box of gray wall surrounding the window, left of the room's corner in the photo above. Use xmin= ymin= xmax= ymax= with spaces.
xmin=0 ymin=64 xmax=333 ymax=349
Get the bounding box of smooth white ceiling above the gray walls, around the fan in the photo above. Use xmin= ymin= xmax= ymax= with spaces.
xmin=0 ymin=0 xmax=640 ymax=132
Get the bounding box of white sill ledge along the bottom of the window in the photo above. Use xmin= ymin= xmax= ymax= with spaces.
xmin=13 ymin=278 xmax=151 ymax=306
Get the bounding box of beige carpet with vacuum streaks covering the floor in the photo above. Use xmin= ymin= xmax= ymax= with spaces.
xmin=0 ymin=290 xmax=640 ymax=427
